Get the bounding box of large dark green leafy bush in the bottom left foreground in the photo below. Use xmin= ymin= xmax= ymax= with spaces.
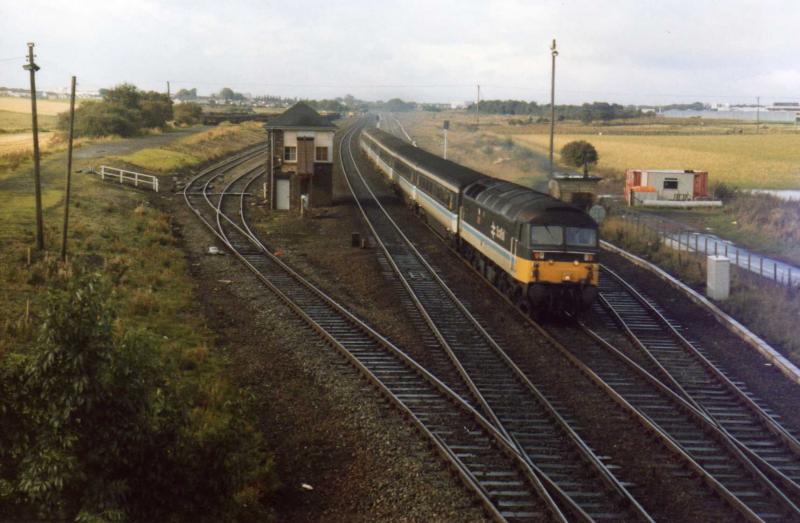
xmin=0 ymin=276 xmax=276 ymax=521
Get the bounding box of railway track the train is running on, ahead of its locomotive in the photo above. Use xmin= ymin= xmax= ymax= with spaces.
xmin=346 ymin=121 xmax=800 ymax=521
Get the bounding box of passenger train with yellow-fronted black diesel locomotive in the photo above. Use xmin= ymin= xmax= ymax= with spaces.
xmin=359 ymin=127 xmax=600 ymax=315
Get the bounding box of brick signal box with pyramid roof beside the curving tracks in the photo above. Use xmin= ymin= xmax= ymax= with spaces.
xmin=264 ymin=102 xmax=336 ymax=210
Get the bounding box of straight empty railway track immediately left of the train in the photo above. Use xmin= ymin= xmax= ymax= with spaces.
xmin=340 ymin=121 xmax=651 ymax=521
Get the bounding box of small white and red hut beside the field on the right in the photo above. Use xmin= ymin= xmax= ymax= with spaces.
xmin=625 ymin=169 xmax=721 ymax=207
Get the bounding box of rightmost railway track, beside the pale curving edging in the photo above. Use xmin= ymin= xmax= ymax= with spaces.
xmin=595 ymin=269 xmax=800 ymax=503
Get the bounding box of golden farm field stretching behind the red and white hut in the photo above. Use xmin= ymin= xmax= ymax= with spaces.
xmin=396 ymin=111 xmax=800 ymax=189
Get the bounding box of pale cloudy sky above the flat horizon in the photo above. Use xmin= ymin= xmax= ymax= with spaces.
xmin=0 ymin=0 xmax=800 ymax=105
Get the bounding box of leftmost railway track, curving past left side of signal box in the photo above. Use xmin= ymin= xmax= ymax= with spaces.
xmin=184 ymin=144 xmax=580 ymax=521
